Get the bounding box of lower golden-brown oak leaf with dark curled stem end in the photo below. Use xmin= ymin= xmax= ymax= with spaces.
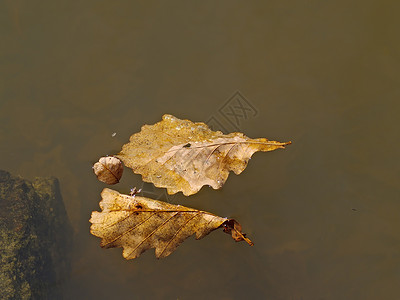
xmin=89 ymin=188 xmax=253 ymax=259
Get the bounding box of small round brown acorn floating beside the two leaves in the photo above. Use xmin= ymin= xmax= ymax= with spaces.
xmin=93 ymin=156 xmax=124 ymax=184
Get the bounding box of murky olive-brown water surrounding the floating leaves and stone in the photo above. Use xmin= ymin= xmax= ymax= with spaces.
xmin=0 ymin=0 xmax=400 ymax=300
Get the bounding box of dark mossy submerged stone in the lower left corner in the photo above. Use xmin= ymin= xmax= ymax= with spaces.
xmin=0 ymin=170 xmax=73 ymax=299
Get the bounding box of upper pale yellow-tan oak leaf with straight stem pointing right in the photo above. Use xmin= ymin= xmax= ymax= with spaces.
xmin=116 ymin=115 xmax=290 ymax=196
